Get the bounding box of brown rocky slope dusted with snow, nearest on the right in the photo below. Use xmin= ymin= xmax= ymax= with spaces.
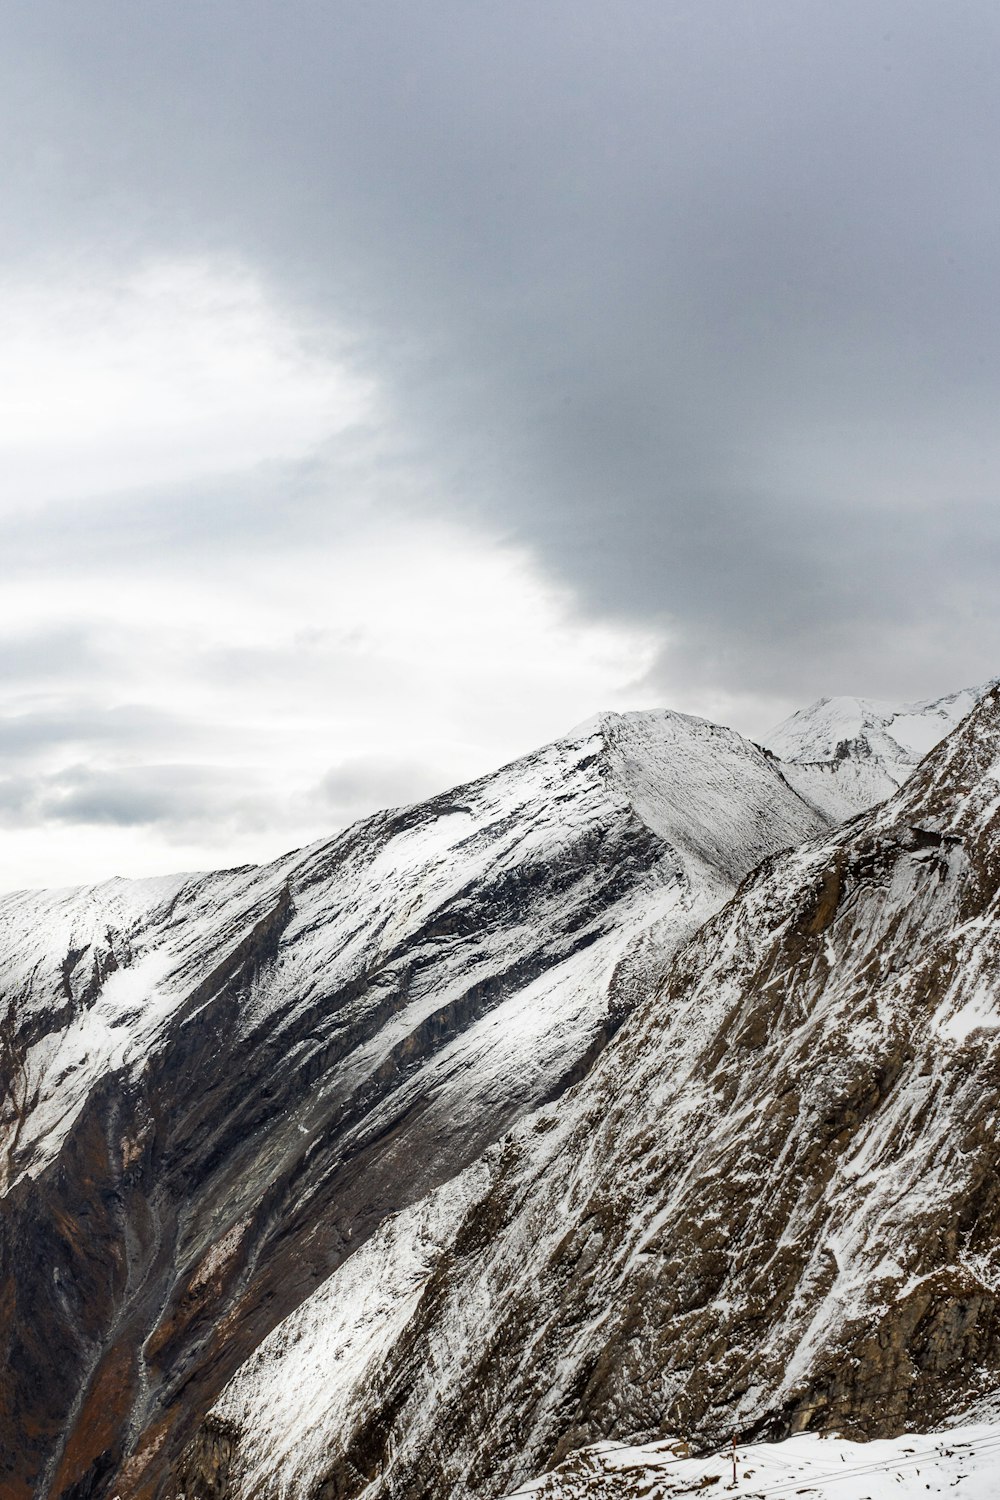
xmin=205 ymin=690 xmax=1000 ymax=1500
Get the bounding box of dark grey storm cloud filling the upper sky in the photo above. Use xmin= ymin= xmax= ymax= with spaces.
xmin=0 ymin=0 xmax=1000 ymax=696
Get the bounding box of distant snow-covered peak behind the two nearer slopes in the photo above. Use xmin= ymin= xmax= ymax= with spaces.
xmin=763 ymin=678 xmax=1000 ymax=822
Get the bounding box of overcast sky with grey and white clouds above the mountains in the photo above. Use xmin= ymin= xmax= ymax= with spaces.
xmin=0 ymin=0 xmax=1000 ymax=887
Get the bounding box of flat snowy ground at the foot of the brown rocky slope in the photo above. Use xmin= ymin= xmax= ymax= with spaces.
xmin=514 ymin=1424 xmax=1000 ymax=1500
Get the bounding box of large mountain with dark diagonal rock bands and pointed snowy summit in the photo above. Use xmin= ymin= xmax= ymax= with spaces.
xmin=0 ymin=714 xmax=825 ymax=1500
